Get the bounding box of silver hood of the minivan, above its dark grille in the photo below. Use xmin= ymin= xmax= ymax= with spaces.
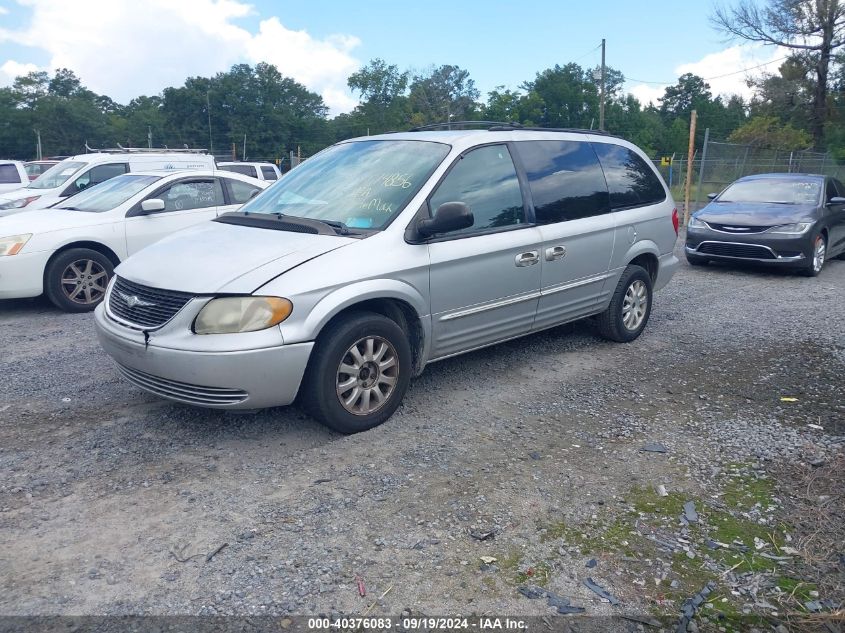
xmin=115 ymin=222 xmax=357 ymax=294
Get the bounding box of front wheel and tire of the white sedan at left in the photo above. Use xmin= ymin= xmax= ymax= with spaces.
xmin=44 ymin=248 xmax=114 ymax=312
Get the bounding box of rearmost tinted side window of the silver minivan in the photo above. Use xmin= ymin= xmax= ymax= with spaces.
xmin=593 ymin=143 xmax=666 ymax=209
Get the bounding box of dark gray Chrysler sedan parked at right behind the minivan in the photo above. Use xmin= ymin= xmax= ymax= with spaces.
xmin=684 ymin=174 xmax=845 ymax=276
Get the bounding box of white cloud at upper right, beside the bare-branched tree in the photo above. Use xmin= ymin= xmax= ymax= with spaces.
xmin=627 ymin=44 xmax=789 ymax=105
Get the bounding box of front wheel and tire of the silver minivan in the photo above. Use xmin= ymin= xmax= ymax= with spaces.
xmin=301 ymin=312 xmax=411 ymax=434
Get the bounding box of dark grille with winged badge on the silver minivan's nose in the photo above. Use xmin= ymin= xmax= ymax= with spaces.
xmin=108 ymin=277 xmax=194 ymax=329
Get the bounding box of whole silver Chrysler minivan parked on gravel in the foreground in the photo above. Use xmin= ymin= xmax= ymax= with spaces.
xmin=96 ymin=126 xmax=678 ymax=433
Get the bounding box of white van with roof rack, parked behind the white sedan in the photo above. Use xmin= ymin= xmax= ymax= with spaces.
xmin=0 ymin=148 xmax=215 ymax=216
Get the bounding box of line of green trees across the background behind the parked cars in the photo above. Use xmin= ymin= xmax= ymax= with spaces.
xmin=0 ymin=0 xmax=845 ymax=166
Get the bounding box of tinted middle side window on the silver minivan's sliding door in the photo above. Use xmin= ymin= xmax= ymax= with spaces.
xmin=515 ymin=141 xmax=610 ymax=224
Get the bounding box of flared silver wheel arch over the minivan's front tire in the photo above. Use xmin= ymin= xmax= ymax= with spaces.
xmin=282 ymin=279 xmax=431 ymax=348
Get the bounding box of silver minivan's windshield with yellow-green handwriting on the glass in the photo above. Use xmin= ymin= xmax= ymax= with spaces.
xmin=240 ymin=140 xmax=450 ymax=229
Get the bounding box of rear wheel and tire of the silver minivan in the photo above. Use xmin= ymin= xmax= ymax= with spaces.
xmin=598 ymin=265 xmax=653 ymax=343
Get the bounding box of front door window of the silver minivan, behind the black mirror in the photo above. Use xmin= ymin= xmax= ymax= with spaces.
xmin=429 ymin=145 xmax=525 ymax=236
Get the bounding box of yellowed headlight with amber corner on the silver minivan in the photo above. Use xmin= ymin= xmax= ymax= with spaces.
xmin=194 ymin=297 xmax=293 ymax=334
